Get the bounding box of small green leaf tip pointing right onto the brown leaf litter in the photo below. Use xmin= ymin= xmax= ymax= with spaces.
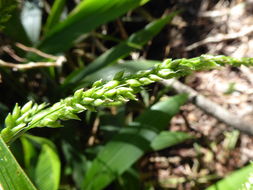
xmin=151 ymin=131 xmax=193 ymax=151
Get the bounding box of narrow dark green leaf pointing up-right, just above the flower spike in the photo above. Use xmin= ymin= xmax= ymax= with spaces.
xmin=62 ymin=12 xmax=176 ymax=87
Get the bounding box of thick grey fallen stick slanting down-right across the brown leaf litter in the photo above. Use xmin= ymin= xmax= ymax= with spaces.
xmin=163 ymin=79 xmax=253 ymax=135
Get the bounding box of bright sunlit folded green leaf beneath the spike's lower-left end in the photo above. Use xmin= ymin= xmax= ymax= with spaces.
xmin=21 ymin=134 xmax=61 ymax=190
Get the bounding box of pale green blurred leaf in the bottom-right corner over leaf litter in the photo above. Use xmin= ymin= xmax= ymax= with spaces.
xmin=206 ymin=164 xmax=253 ymax=190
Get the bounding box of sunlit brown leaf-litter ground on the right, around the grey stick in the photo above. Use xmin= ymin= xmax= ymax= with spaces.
xmin=141 ymin=0 xmax=253 ymax=190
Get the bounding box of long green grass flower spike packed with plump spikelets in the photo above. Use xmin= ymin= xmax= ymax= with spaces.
xmin=1 ymin=55 xmax=253 ymax=143
